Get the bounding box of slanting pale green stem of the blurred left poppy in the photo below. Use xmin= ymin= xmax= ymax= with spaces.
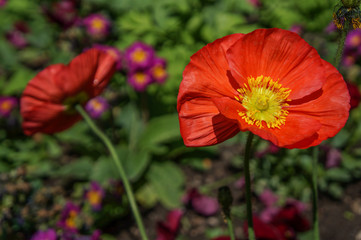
xmin=75 ymin=105 xmax=148 ymax=240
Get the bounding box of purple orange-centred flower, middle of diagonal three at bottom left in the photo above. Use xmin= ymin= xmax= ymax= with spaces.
xmin=57 ymin=202 xmax=80 ymax=232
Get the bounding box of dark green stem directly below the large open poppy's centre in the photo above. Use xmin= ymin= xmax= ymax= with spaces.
xmin=243 ymin=132 xmax=256 ymax=240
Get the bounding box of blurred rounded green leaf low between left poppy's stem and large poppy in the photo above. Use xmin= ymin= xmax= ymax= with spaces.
xmin=147 ymin=162 xmax=184 ymax=209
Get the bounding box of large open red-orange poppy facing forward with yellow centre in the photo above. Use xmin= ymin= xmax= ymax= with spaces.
xmin=177 ymin=29 xmax=350 ymax=148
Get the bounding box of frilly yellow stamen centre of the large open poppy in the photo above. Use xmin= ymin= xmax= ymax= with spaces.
xmin=235 ymin=75 xmax=291 ymax=128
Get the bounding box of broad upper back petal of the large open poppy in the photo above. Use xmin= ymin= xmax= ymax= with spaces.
xmin=226 ymin=28 xmax=325 ymax=99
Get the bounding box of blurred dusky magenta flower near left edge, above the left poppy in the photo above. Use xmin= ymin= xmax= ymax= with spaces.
xmin=5 ymin=22 xmax=29 ymax=49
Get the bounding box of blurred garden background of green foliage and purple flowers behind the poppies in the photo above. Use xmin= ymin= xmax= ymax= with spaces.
xmin=0 ymin=0 xmax=361 ymax=240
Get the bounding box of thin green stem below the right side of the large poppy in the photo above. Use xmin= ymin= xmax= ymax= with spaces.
xmin=312 ymin=147 xmax=320 ymax=240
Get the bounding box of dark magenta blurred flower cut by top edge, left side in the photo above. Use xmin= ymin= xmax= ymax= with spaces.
xmin=44 ymin=0 xmax=79 ymax=29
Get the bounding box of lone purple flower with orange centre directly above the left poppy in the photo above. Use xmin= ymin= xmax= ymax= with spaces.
xmin=83 ymin=13 xmax=111 ymax=38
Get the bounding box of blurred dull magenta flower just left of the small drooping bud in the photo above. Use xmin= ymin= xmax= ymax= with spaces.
xmin=183 ymin=188 xmax=219 ymax=216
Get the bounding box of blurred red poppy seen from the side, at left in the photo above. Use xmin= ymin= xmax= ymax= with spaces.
xmin=20 ymin=49 xmax=116 ymax=135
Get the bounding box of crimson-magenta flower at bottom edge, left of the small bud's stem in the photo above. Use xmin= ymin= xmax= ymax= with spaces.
xmin=156 ymin=209 xmax=183 ymax=240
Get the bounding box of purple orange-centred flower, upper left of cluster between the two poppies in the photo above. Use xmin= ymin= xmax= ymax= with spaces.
xmin=125 ymin=42 xmax=155 ymax=71
